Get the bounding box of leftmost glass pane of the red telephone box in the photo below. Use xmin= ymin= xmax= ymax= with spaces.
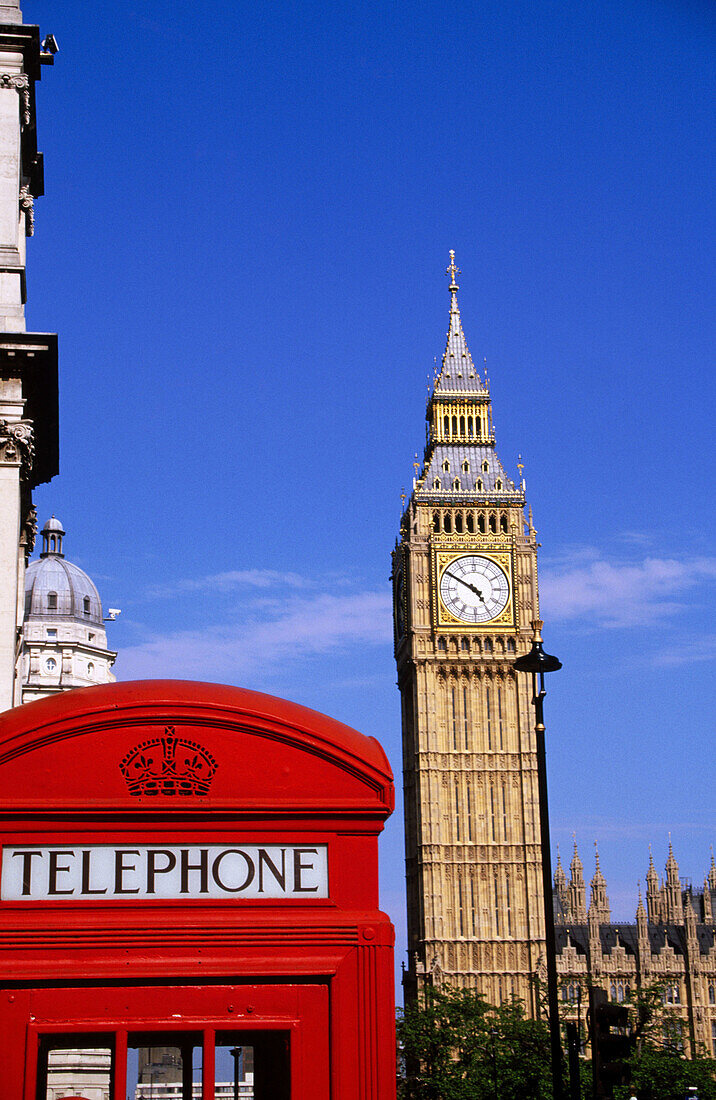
xmin=37 ymin=1036 xmax=112 ymax=1100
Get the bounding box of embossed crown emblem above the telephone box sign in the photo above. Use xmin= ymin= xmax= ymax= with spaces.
xmin=120 ymin=726 xmax=218 ymax=798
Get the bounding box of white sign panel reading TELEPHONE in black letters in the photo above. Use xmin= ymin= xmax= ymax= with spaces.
xmin=0 ymin=845 xmax=328 ymax=901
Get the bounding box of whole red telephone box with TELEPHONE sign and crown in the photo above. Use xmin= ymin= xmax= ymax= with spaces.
xmin=0 ymin=681 xmax=395 ymax=1100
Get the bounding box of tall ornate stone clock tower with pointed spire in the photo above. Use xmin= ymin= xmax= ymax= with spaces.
xmin=393 ymin=252 xmax=544 ymax=1014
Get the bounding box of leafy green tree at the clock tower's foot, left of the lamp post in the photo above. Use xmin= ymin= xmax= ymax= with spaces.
xmin=398 ymin=988 xmax=552 ymax=1100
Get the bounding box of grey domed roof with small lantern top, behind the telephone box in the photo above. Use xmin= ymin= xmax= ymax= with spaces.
xmin=25 ymin=516 xmax=102 ymax=626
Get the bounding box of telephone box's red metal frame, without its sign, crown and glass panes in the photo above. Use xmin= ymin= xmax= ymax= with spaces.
xmin=0 ymin=681 xmax=395 ymax=1100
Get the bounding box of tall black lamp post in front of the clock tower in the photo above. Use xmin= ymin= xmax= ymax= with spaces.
xmin=513 ymin=619 xmax=563 ymax=1100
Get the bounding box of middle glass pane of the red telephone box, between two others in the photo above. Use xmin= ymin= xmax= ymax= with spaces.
xmin=126 ymin=1032 xmax=201 ymax=1100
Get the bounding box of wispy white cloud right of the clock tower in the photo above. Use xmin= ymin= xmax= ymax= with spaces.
xmin=540 ymin=548 xmax=716 ymax=627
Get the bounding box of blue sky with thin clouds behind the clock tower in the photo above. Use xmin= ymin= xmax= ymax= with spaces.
xmin=23 ymin=0 xmax=716 ymax=981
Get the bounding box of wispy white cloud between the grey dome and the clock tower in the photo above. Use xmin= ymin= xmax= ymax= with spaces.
xmin=118 ymin=592 xmax=392 ymax=680
